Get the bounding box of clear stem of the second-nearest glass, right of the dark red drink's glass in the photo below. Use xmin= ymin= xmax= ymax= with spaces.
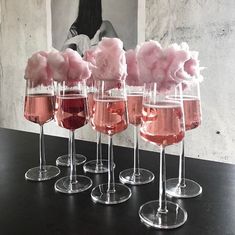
xmin=107 ymin=135 xmax=115 ymax=193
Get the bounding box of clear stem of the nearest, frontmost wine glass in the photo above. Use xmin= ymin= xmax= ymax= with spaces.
xmin=158 ymin=146 xmax=167 ymax=213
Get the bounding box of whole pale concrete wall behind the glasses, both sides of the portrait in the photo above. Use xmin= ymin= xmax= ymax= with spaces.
xmin=0 ymin=0 xmax=235 ymax=163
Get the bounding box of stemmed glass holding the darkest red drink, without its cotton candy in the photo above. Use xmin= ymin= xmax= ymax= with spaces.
xmin=55 ymin=80 xmax=92 ymax=194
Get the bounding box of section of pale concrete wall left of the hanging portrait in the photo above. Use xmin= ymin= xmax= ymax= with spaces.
xmin=0 ymin=0 xmax=51 ymax=134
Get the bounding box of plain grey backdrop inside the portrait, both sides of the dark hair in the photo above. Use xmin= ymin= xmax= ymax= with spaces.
xmin=51 ymin=0 xmax=138 ymax=49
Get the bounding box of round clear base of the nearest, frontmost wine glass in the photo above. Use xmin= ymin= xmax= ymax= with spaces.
xmin=139 ymin=201 xmax=187 ymax=229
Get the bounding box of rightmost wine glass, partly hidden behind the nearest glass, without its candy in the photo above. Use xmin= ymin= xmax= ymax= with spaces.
xmin=166 ymin=81 xmax=202 ymax=198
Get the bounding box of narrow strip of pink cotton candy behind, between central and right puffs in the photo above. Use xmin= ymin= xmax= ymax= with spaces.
xmin=125 ymin=50 xmax=144 ymax=86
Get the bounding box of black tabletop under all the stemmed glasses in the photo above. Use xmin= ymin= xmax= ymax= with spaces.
xmin=0 ymin=129 xmax=235 ymax=235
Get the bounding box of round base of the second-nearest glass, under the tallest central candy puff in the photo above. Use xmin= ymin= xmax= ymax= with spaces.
xmin=91 ymin=183 xmax=131 ymax=205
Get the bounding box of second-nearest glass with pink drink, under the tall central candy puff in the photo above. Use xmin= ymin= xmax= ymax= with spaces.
xmin=91 ymin=80 xmax=131 ymax=204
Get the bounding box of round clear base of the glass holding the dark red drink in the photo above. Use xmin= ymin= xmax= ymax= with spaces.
xmin=55 ymin=175 xmax=92 ymax=194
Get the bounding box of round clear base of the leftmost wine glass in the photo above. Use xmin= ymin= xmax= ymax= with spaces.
xmin=25 ymin=165 xmax=60 ymax=181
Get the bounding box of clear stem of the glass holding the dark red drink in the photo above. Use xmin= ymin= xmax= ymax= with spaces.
xmin=69 ymin=130 xmax=76 ymax=184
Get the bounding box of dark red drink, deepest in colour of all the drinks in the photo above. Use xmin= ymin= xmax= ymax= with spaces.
xmin=55 ymin=94 xmax=87 ymax=130
